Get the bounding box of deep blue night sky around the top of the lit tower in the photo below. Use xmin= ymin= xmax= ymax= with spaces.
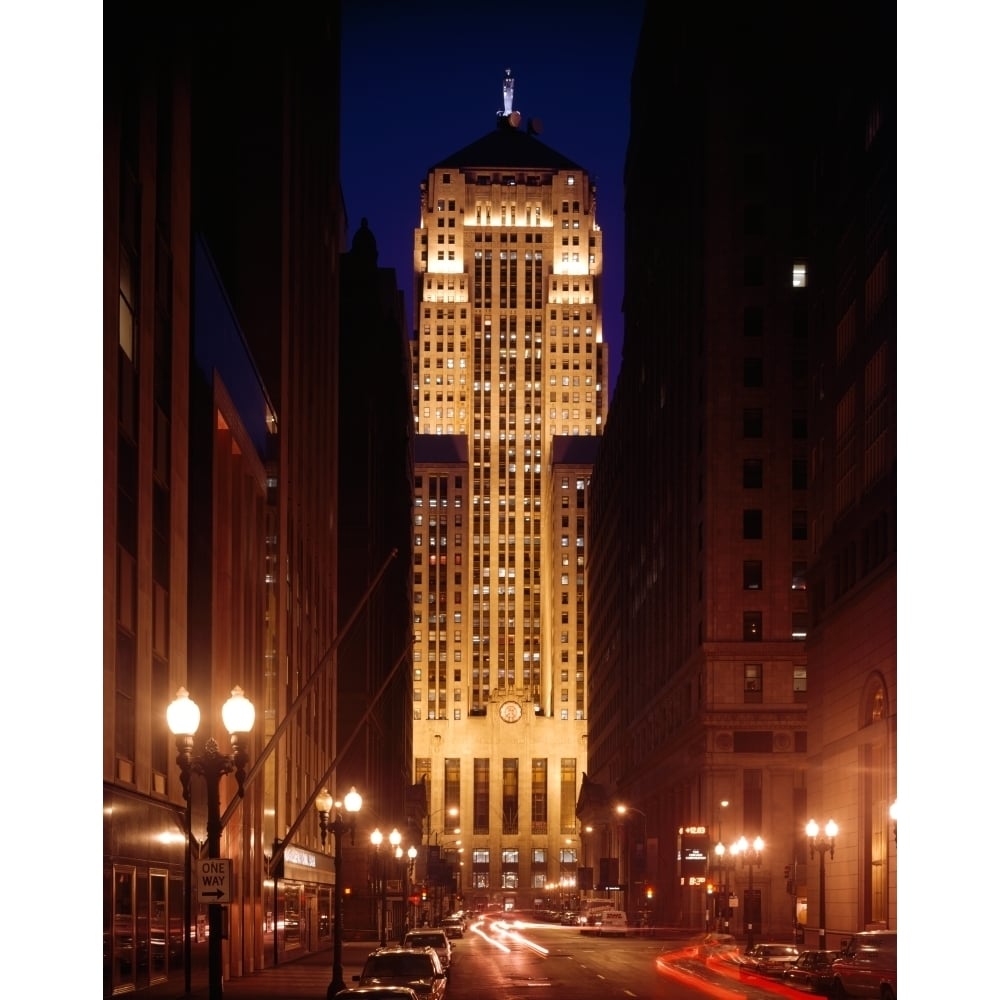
xmin=341 ymin=0 xmax=644 ymax=398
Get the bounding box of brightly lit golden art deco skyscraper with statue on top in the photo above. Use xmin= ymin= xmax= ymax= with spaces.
xmin=412 ymin=70 xmax=607 ymax=917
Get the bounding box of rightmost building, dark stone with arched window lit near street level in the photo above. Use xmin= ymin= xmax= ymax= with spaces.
xmin=807 ymin=4 xmax=898 ymax=947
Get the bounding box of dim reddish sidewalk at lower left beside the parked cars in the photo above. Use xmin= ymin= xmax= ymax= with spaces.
xmin=179 ymin=941 xmax=378 ymax=1000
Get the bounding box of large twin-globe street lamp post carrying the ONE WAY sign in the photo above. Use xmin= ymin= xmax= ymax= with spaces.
xmin=167 ymin=686 xmax=255 ymax=1000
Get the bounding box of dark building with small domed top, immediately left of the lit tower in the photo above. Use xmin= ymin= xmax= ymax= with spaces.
xmin=337 ymin=219 xmax=420 ymax=938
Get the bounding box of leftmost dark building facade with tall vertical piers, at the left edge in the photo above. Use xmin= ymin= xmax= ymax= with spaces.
xmin=102 ymin=15 xmax=200 ymax=996
